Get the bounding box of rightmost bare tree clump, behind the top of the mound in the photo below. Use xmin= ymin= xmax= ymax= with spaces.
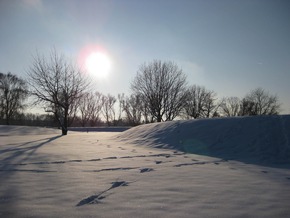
xmin=240 ymin=88 xmax=280 ymax=116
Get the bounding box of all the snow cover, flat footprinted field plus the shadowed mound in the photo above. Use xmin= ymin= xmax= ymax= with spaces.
xmin=0 ymin=116 xmax=290 ymax=217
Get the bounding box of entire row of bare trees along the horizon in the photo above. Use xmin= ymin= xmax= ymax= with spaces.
xmin=0 ymin=50 xmax=280 ymax=135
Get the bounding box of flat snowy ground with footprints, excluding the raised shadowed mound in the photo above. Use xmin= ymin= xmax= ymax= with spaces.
xmin=0 ymin=123 xmax=290 ymax=217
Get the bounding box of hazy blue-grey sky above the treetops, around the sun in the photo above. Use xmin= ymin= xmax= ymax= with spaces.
xmin=0 ymin=0 xmax=290 ymax=114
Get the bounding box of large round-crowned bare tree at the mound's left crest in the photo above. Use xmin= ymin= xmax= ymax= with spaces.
xmin=131 ymin=60 xmax=186 ymax=122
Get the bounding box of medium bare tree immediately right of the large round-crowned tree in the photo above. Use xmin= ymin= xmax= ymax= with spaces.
xmin=184 ymin=85 xmax=218 ymax=119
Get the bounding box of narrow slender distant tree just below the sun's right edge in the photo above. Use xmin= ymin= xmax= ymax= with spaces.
xmin=102 ymin=94 xmax=117 ymax=126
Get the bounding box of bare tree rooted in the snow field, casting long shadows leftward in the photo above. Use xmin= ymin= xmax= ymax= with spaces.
xmin=28 ymin=50 xmax=89 ymax=135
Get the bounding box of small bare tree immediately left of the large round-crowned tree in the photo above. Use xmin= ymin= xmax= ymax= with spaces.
xmin=122 ymin=94 xmax=144 ymax=126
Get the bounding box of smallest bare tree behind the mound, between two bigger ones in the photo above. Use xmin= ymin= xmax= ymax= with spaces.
xmin=220 ymin=97 xmax=241 ymax=117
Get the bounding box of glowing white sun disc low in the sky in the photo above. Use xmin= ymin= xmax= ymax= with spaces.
xmin=85 ymin=52 xmax=111 ymax=78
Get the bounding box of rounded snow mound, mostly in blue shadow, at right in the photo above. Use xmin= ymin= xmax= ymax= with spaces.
xmin=118 ymin=115 xmax=290 ymax=164
